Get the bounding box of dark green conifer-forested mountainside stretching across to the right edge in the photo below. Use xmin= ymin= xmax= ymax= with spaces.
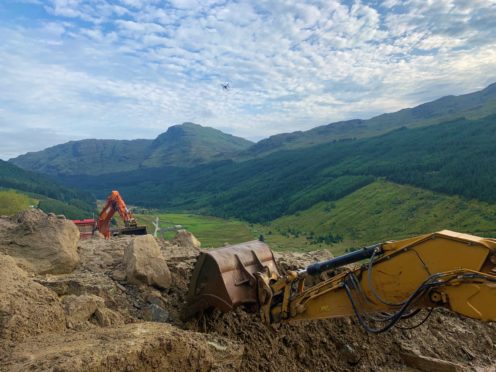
xmin=57 ymin=115 xmax=496 ymax=222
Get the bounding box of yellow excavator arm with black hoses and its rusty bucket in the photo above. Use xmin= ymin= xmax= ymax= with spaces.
xmin=184 ymin=230 xmax=496 ymax=333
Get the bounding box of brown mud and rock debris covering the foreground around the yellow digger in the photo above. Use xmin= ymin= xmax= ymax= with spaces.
xmin=0 ymin=215 xmax=496 ymax=371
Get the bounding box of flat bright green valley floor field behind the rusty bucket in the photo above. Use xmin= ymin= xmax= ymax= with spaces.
xmin=136 ymin=213 xmax=256 ymax=248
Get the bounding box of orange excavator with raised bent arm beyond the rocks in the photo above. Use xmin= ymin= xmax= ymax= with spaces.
xmin=94 ymin=190 xmax=146 ymax=239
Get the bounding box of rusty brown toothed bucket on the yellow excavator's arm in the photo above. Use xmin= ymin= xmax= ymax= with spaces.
xmin=184 ymin=240 xmax=279 ymax=319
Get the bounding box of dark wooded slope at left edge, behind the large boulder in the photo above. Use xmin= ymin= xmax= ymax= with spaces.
xmin=0 ymin=160 xmax=96 ymax=219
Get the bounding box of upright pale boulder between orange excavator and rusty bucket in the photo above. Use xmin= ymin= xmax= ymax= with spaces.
xmin=124 ymin=235 xmax=172 ymax=288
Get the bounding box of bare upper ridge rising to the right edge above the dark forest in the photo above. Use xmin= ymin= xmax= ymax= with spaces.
xmin=242 ymin=83 xmax=496 ymax=158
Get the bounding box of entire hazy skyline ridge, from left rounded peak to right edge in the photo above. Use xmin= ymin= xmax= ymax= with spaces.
xmin=9 ymin=83 xmax=496 ymax=176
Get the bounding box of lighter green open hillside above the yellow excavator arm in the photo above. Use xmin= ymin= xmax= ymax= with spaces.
xmin=266 ymin=180 xmax=496 ymax=251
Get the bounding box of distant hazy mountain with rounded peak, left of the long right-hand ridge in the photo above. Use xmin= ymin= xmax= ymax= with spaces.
xmin=10 ymin=123 xmax=253 ymax=175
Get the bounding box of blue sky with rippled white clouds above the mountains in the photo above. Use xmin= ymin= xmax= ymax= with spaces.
xmin=0 ymin=0 xmax=496 ymax=159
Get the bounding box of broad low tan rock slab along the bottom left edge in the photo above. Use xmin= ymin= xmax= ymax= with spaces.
xmin=0 ymin=322 xmax=244 ymax=372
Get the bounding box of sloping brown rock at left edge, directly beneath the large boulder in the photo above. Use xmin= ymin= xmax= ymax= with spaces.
xmin=0 ymin=254 xmax=66 ymax=342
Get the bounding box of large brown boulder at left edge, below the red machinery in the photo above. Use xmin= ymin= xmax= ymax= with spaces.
xmin=0 ymin=209 xmax=79 ymax=274
